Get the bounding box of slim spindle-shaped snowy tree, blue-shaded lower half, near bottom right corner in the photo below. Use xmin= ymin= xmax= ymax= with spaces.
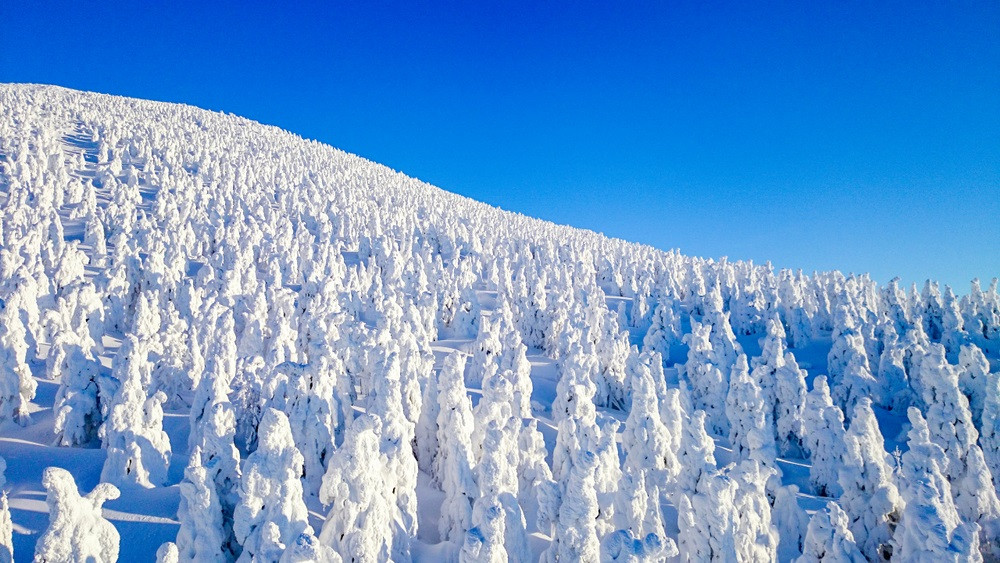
xmin=838 ymin=399 xmax=903 ymax=560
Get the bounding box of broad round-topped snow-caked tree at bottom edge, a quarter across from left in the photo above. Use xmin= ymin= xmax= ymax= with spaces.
xmin=233 ymin=409 xmax=312 ymax=561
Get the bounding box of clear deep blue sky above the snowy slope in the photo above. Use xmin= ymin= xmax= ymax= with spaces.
xmin=0 ymin=1 xmax=1000 ymax=293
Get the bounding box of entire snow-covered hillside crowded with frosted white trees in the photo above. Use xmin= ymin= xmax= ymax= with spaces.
xmin=0 ymin=85 xmax=1000 ymax=563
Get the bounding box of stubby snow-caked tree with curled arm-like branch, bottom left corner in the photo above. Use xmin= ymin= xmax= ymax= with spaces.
xmin=35 ymin=467 xmax=120 ymax=563
